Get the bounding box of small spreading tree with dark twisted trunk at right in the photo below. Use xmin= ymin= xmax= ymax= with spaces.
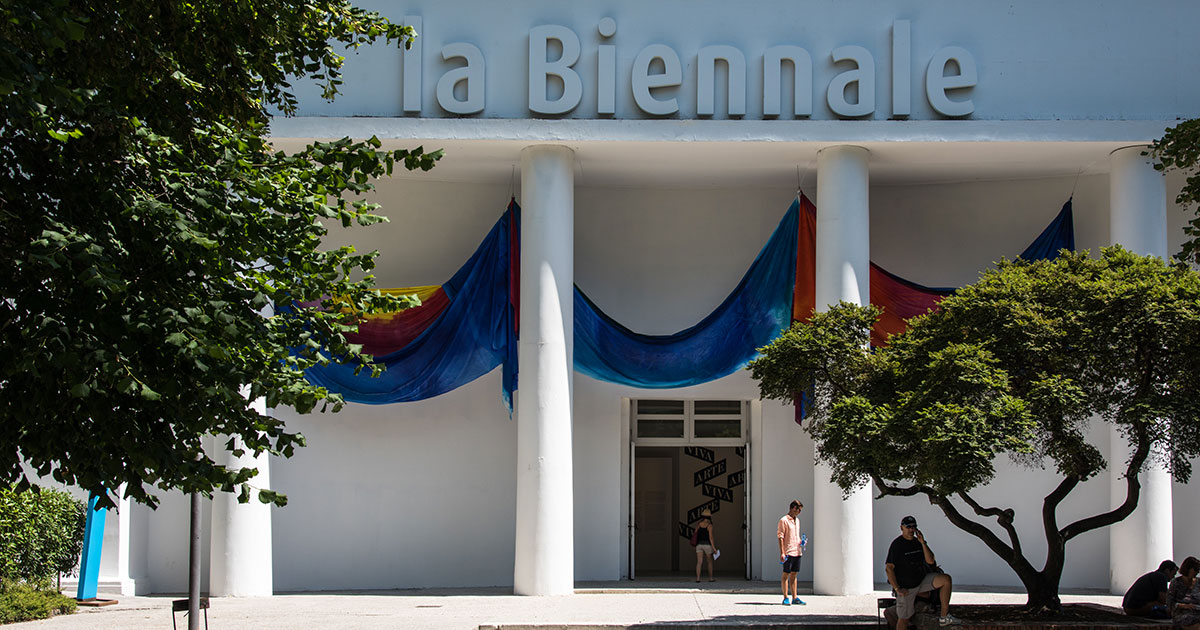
xmin=750 ymin=247 xmax=1200 ymax=611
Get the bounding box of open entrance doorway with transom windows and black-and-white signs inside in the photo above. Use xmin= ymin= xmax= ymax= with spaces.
xmin=630 ymin=400 xmax=750 ymax=580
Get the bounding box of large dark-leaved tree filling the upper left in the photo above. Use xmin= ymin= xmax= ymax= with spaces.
xmin=0 ymin=0 xmax=440 ymax=505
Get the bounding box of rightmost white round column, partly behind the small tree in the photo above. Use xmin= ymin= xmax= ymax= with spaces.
xmin=1109 ymin=145 xmax=1175 ymax=593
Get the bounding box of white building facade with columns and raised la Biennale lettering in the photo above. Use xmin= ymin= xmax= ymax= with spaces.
xmin=75 ymin=0 xmax=1200 ymax=595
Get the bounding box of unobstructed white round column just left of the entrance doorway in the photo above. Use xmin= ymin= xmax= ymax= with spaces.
xmin=512 ymin=145 xmax=575 ymax=595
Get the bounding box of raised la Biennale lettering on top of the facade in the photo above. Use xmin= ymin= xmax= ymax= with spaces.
xmin=393 ymin=16 xmax=978 ymax=119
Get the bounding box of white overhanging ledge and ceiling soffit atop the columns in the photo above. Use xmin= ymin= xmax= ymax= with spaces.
xmin=272 ymin=118 xmax=1171 ymax=188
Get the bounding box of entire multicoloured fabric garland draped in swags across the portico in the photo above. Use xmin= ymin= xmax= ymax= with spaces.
xmin=306 ymin=194 xmax=1074 ymax=412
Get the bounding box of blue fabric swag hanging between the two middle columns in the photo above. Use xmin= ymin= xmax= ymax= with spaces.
xmin=575 ymin=202 xmax=799 ymax=389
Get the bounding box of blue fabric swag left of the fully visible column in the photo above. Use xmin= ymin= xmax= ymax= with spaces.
xmin=306 ymin=204 xmax=520 ymax=412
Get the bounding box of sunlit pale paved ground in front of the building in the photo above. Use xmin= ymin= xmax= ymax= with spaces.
xmin=16 ymin=580 xmax=1121 ymax=630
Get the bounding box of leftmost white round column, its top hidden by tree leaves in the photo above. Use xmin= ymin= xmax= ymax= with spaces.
xmin=209 ymin=398 xmax=275 ymax=598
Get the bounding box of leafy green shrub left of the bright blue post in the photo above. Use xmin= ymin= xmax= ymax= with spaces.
xmin=0 ymin=486 xmax=86 ymax=588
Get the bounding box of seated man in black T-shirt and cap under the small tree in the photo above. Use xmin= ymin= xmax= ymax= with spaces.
xmin=883 ymin=516 xmax=958 ymax=630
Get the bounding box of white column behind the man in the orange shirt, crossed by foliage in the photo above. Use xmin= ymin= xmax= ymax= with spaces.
xmin=809 ymin=146 xmax=875 ymax=595
